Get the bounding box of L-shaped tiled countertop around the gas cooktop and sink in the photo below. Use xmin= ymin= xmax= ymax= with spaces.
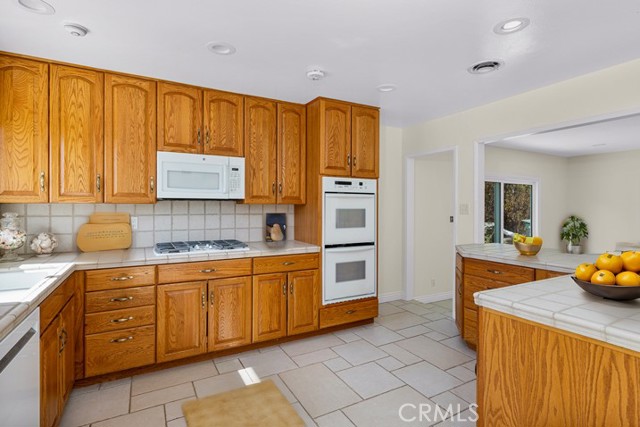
xmin=0 ymin=240 xmax=320 ymax=340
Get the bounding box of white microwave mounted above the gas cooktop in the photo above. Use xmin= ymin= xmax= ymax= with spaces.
xmin=157 ymin=151 xmax=244 ymax=199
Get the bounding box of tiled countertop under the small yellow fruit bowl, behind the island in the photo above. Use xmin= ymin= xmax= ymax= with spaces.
xmin=456 ymin=243 xmax=599 ymax=274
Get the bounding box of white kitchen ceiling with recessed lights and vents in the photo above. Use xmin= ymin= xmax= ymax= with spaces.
xmin=0 ymin=0 xmax=640 ymax=126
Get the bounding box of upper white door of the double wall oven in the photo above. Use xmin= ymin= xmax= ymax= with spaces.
xmin=324 ymin=193 xmax=376 ymax=246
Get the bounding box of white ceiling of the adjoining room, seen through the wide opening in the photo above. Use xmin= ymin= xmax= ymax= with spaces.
xmin=491 ymin=114 xmax=640 ymax=157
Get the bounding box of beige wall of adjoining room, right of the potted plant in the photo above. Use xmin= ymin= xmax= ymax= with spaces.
xmin=567 ymin=150 xmax=640 ymax=253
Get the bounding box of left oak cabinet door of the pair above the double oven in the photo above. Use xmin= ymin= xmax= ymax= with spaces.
xmin=320 ymin=100 xmax=351 ymax=176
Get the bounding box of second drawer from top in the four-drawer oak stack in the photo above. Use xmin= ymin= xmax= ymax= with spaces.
xmin=85 ymin=286 xmax=156 ymax=313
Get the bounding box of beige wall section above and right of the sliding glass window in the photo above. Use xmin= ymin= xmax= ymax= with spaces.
xmin=484 ymin=145 xmax=570 ymax=249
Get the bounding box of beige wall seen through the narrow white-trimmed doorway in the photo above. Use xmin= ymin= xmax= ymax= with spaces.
xmin=413 ymin=151 xmax=454 ymax=299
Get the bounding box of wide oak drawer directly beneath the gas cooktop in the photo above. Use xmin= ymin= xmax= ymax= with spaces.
xmin=158 ymin=258 xmax=251 ymax=283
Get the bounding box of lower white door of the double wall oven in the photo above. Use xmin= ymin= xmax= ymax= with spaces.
xmin=322 ymin=245 xmax=376 ymax=304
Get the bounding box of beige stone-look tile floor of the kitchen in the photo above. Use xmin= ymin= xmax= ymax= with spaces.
xmin=61 ymin=300 xmax=476 ymax=427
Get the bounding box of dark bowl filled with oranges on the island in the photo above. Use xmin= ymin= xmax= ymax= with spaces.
xmin=571 ymin=252 xmax=640 ymax=301
